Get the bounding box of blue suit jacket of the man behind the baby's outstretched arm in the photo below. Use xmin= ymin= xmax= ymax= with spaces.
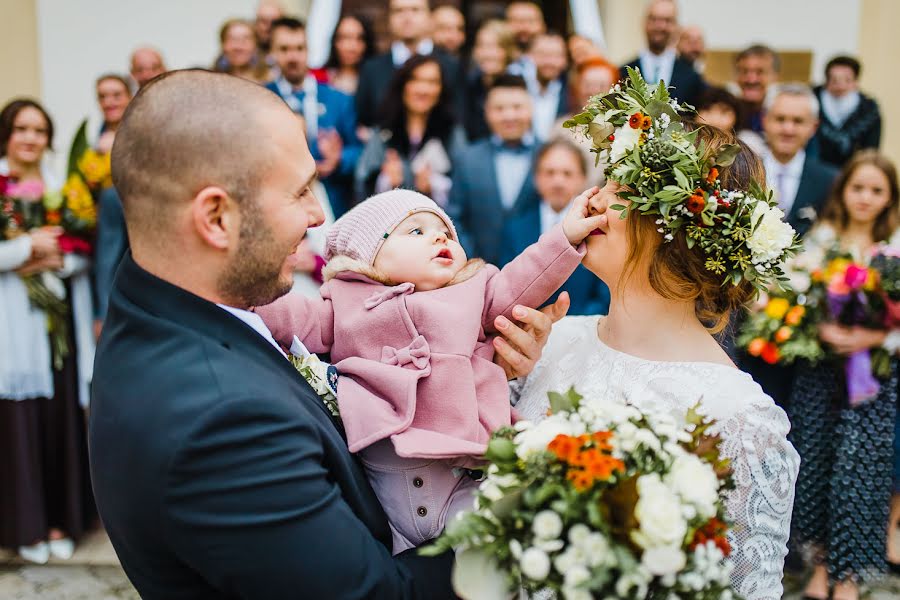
xmin=498 ymin=206 xmax=609 ymax=315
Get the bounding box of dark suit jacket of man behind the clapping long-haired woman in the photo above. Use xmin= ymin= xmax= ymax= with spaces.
xmin=356 ymin=48 xmax=462 ymax=127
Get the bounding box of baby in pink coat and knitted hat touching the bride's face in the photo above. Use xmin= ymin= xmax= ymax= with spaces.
xmin=256 ymin=188 xmax=601 ymax=554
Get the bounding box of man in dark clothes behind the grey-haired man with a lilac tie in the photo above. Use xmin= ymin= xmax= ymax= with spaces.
xmin=734 ymin=44 xmax=781 ymax=133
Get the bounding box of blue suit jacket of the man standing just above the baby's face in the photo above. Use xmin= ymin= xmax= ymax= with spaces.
xmin=447 ymin=139 xmax=539 ymax=265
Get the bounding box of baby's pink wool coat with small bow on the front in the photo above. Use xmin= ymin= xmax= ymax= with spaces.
xmin=256 ymin=226 xmax=584 ymax=459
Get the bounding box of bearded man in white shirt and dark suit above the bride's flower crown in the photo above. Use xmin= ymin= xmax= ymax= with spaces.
xmin=622 ymin=0 xmax=706 ymax=105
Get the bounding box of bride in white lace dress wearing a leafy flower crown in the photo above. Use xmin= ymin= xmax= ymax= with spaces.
xmin=516 ymin=72 xmax=799 ymax=600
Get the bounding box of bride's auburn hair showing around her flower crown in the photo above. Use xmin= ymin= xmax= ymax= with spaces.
xmin=623 ymin=123 xmax=766 ymax=333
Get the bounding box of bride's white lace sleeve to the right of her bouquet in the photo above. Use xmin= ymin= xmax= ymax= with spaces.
xmin=721 ymin=393 xmax=800 ymax=600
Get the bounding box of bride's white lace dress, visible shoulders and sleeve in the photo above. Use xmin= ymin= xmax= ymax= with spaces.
xmin=516 ymin=316 xmax=800 ymax=600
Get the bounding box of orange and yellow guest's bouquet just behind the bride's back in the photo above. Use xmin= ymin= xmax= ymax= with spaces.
xmin=737 ymin=295 xmax=825 ymax=365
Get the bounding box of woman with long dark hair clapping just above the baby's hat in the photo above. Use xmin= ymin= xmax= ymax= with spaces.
xmin=356 ymin=55 xmax=466 ymax=206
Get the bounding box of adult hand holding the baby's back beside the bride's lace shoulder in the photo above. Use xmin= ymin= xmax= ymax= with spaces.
xmin=494 ymin=292 xmax=569 ymax=379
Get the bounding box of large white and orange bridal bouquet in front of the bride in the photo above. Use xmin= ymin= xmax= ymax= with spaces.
xmin=421 ymin=390 xmax=734 ymax=600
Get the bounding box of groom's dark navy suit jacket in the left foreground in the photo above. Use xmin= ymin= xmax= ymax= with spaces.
xmin=90 ymin=253 xmax=452 ymax=600
